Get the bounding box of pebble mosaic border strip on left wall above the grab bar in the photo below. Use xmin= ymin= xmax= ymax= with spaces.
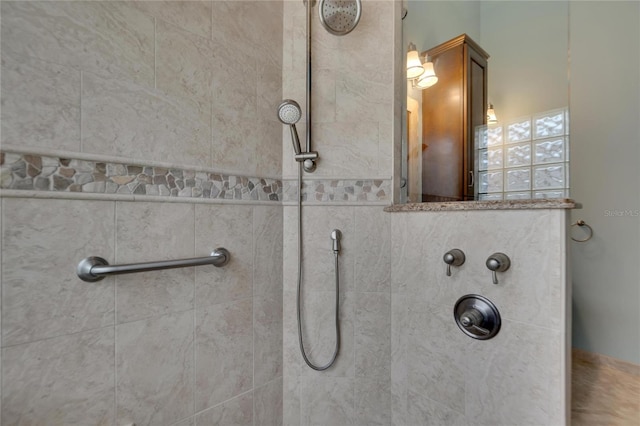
xmin=0 ymin=151 xmax=282 ymax=202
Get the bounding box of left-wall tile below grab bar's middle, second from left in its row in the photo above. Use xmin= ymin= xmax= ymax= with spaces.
xmin=116 ymin=311 xmax=194 ymax=425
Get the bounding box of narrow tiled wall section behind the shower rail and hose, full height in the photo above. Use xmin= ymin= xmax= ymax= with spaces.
xmin=282 ymin=0 xmax=400 ymax=425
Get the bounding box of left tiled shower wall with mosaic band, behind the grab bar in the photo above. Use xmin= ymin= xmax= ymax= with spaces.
xmin=0 ymin=1 xmax=283 ymax=425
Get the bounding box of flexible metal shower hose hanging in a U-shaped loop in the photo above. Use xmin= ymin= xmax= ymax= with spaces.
xmin=296 ymin=163 xmax=340 ymax=371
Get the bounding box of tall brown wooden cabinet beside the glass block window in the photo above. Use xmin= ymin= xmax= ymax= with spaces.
xmin=422 ymin=34 xmax=489 ymax=201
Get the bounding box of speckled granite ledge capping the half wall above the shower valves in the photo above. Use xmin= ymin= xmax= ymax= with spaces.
xmin=384 ymin=198 xmax=580 ymax=213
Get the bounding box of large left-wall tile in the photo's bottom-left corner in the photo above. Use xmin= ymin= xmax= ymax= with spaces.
xmin=2 ymin=327 xmax=115 ymax=426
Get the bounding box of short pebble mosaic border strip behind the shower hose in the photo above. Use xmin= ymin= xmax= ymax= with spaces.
xmin=283 ymin=179 xmax=391 ymax=203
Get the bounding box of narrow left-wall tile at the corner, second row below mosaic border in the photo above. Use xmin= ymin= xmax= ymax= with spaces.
xmin=253 ymin=296 xmax=282 ymax=387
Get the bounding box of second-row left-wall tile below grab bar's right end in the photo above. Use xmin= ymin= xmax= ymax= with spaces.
xmin=196 ymin=299 xmax=253 ymax=411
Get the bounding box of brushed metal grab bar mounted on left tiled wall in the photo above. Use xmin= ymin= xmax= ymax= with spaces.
xmin=76 ymin=247 xmax=231 ymax=282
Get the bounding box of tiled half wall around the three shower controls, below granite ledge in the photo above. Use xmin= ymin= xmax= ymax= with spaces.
xmin=391 ymin=209 xmax=571 ymax=425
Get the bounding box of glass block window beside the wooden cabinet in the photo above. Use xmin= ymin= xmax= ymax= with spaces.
xmin=474 ymin=108 xmax=569 ymax=200
